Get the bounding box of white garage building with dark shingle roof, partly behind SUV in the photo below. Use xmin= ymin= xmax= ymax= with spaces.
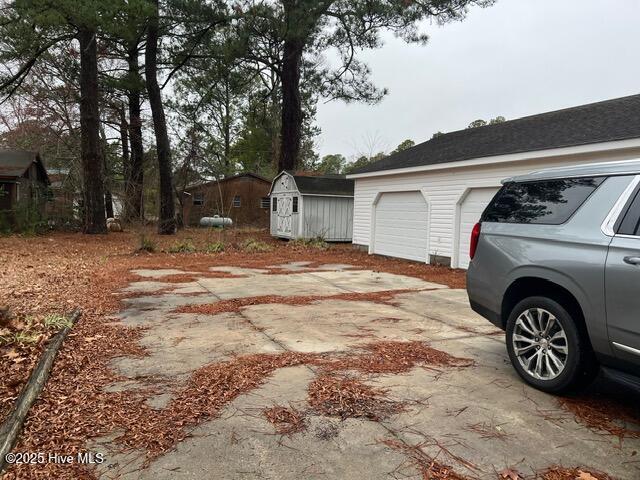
xmin=348 ymin=95 xmax=640 ymax=268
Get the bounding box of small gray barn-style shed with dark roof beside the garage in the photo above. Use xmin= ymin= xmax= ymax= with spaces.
xmin=269 ymin=171 xmax=354 ymax=242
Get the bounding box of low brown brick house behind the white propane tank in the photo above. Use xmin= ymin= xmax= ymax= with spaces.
xmin=182 ymin=173 xmax=271 ymax=227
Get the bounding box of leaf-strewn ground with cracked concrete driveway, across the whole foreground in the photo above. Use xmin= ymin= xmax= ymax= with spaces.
xmin=0 ymin=230 xmax=640 ymax=480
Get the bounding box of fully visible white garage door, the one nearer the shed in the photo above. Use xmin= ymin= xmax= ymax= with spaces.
xmin=373 ymin=192 xmax=427 ymax=262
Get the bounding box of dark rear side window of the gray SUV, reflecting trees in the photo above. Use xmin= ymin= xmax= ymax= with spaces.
xmin=482 ymin=177 xmax=604 ymax=225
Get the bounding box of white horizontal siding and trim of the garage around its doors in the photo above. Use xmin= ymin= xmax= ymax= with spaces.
xmin=353 ymin=149 xmax=640 ymax=257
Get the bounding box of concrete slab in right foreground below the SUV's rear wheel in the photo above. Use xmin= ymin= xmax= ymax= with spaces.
xmin=375 ymin=344 xmax=638 ymax=480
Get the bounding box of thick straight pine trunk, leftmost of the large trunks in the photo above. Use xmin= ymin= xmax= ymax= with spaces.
xmin=78 ymin=28 xmax=107 ymax=233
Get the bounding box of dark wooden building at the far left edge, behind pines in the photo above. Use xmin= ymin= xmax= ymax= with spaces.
xmin=0 ymin=150 xmax=50 ymax=216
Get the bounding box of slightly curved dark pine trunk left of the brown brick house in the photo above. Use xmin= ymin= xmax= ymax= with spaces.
xmin=144 ymin=0 xmax=176 ymax=235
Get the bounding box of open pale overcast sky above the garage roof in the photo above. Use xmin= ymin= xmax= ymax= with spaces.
xmin=316 ymin=0 xmax=640 ymax=158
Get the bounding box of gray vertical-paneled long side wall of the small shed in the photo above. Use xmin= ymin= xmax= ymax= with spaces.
xmin=301 ymin=195 xmax=353 ymax=242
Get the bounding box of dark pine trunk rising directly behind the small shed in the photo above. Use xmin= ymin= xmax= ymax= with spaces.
xmin=278 ymin=38 xmax=304 ymax=171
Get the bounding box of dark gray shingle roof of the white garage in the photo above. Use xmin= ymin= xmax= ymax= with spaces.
xmin=353 ymin=95 xmax=640 ymax=174
